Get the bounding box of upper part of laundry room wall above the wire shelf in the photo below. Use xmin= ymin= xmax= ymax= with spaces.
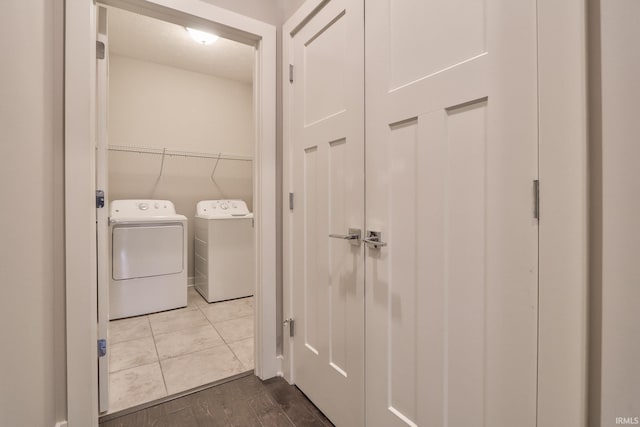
xmin=109 ymin=55 xmax=253 ymax=156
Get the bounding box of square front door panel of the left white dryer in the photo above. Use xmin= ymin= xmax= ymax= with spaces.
xmin=112 ymin=224 xmax=185 ymax=280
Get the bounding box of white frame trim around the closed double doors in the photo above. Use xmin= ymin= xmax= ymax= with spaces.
xmin=282 ymin=0 xmax=588 ymax=427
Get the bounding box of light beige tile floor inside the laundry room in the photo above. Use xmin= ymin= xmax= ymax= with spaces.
xmin=109 ymin=287 xmax=254 ymax=413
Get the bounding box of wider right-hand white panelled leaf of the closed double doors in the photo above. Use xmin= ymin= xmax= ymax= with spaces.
xmin=366 ymin=0 xmax=538 ymax=427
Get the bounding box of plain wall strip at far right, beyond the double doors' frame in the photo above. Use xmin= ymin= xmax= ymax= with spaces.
xmin=590 ymin=0 xmax=640 ymax=427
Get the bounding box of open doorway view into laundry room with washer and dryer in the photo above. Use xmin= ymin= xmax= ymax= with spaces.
xmin=96 ymin=6 xmax=268 ymax=416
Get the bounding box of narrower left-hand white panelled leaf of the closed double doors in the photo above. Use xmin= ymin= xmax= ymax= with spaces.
xmin=291 ymin=0 xmax=364 ymax=426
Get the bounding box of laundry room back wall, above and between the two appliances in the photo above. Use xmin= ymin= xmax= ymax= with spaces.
xmin=108 ymin=54 xmax=254 ymax=277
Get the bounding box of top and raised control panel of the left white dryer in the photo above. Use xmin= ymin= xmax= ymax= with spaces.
xmin=110 ymin=199 xmax=187 ymax=222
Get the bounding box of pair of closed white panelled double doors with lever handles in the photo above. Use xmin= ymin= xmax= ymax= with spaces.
xmin=289 ymin=0 xmax=538 ymax=427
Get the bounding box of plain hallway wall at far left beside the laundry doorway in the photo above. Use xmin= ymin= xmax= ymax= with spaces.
xmin=0 ymin=0 xmax=66 ymax=427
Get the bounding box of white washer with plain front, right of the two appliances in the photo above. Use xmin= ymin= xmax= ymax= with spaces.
xmin=194 ymin=200 xmax=255 ymax=302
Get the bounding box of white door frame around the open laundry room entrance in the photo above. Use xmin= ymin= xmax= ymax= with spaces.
xmin=65 ymin=0 xmax=280 ymax=427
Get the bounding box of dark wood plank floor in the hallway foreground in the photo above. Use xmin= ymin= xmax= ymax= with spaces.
xmin=100 ymin=375 xmax=333 ymax=427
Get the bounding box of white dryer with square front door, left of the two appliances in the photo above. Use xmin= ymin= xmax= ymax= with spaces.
xmin=109 ymin=200 xmax=188 ymax=320
